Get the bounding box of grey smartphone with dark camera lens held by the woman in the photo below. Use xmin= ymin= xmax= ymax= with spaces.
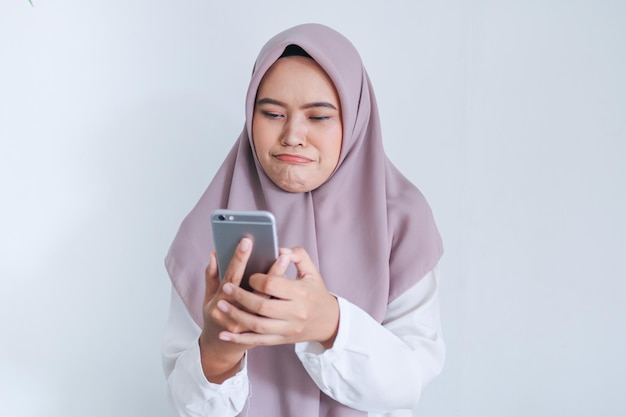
xmin=211 ymin=210 xmax=278 ymax=291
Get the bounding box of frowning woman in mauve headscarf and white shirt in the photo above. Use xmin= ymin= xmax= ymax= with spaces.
xmin=164 ymin=24 xmax=444 ymax=417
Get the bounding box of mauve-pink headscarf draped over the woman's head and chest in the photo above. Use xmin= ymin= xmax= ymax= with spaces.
xmin=166 ymin=24 xmax=443 ymax=417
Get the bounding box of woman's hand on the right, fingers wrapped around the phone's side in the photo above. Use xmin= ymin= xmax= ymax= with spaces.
xmin=220 ymin=248 xmax=339 ymax=349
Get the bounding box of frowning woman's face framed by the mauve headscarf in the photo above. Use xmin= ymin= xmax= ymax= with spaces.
xmin=252 ymin=56 xmax=343 ymax=193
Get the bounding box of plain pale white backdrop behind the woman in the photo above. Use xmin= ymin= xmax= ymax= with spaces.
xmin=0 ymin=0 xmax=626 ymax=417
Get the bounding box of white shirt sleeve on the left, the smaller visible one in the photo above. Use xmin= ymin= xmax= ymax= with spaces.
xmin=162 ymin=289 xmax=249 ymax=417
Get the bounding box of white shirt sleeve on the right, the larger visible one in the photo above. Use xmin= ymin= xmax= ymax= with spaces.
xmin=296 ymin=268 xmax=445 ymax=417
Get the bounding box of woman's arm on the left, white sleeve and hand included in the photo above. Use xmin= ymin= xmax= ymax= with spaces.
xmin=163 ymin=238 xmax=275 ymax=416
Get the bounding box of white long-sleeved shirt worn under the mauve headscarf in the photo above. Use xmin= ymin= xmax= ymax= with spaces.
xmin=163 ymin=268 xmax=445 ymax=417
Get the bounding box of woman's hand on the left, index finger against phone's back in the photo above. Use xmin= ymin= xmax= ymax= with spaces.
xmin=199 ymin=238 xmax=252 ymax=384
